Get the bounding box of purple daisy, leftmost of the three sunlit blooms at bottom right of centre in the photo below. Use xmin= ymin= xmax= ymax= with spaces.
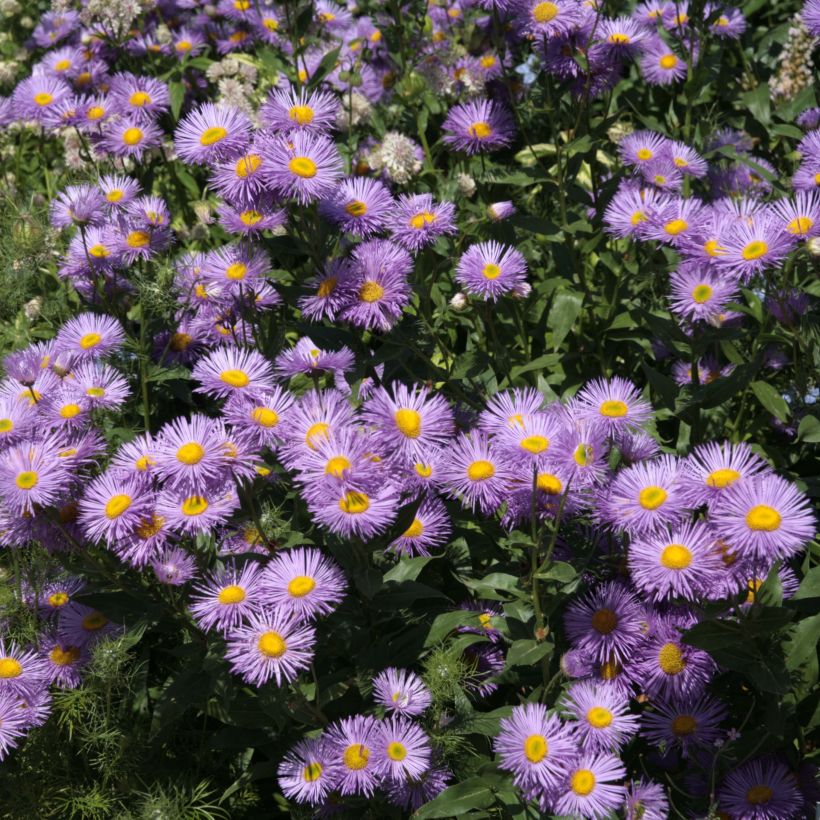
xmin=493 ymin=703 xmax=578 ymax=792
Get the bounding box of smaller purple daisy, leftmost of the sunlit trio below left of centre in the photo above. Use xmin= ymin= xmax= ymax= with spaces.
xmin=190 ymin=562 xmax=263 ymax=634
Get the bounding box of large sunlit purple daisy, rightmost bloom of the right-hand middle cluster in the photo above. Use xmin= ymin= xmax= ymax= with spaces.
xmin=710 ymin=475 xmax=816 ymax=561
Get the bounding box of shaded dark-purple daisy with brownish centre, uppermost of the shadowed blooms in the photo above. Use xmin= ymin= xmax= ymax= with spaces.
xmin=564 ymin=581 xmax=646 ymax=663
